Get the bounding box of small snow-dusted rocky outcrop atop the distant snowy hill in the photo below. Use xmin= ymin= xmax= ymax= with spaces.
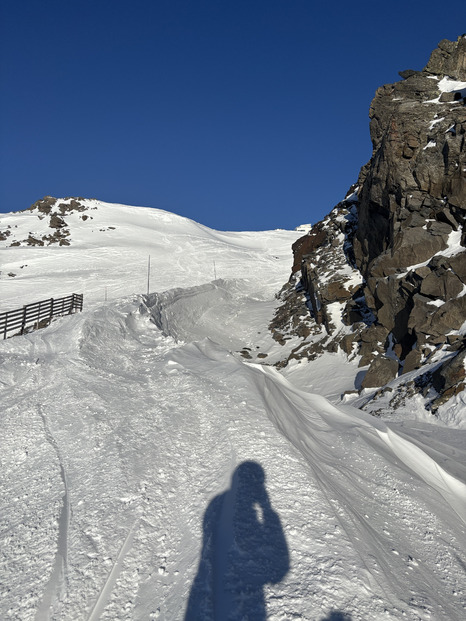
xmin=0 ymin=196 xmax=92 ymax=246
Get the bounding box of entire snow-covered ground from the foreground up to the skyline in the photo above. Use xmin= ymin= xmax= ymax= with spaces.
xmin=0 ymin=201 xmax=466 ymax=621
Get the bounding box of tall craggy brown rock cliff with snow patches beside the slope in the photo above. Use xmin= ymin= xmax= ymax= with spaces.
xmin=271 ymin=36 xmax=466 ymax=409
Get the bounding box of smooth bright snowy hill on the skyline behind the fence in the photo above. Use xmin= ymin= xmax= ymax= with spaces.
xmin=0 ymin=199 xmax=299 ymax=311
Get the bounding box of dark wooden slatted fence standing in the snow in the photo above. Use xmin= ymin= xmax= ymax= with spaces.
xmin=0 ymin=293 xmax=83 ymax=339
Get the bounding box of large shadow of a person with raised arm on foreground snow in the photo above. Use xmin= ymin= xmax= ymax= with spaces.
xmin=185 ymin=461 xmax=290 ymax=621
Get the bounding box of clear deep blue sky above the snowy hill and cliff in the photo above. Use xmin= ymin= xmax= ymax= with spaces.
xmin=0 ymin=0 xmax=466 ymax=230
